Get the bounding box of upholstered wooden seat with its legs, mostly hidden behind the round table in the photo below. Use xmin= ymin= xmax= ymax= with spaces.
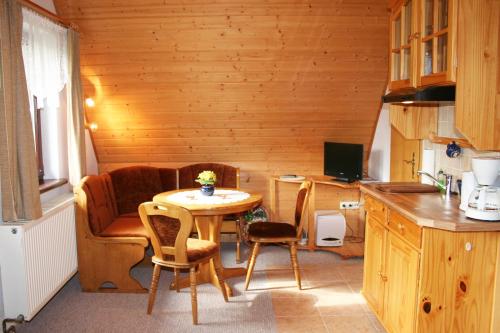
xmin=179 ymin=163 xmax=243 ymax=263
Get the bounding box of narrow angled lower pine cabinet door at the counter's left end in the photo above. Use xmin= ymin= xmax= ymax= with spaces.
xmin=363 ymin=214 xmax=386 ymax=315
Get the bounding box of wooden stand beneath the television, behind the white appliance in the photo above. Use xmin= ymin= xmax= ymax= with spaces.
xmin=269 ymin=176 xmax=365 ymax=259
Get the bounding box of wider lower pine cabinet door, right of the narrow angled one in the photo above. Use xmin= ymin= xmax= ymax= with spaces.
xmin=383 ymin=232 xmax=419 ymax=333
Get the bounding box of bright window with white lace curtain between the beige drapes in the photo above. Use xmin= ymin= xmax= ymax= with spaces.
xmin=22 ymin=8 xmax=69 ymax=189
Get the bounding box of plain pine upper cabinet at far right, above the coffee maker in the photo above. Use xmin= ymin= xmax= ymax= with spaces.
xmin=455 ymin=0 xmax=500 ymax=150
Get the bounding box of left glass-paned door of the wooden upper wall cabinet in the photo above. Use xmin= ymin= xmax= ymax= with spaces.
xmin=390 ymin=0 xmax=415 ymax=89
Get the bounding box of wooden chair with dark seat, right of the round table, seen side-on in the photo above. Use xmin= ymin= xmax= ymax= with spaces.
xmin=245 ymin=181 xmax=311 ymax=290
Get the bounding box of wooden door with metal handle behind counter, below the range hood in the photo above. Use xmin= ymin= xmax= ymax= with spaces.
xmin=391 ymin=126 xmax=420 ymax=182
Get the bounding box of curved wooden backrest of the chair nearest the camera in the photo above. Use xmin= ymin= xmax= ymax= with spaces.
xmin=139 ymin=202 xmax=194 ymax=264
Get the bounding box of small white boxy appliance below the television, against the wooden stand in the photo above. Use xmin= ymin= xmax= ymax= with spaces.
xmin=314 ymin=210 xmax=346 ymax=246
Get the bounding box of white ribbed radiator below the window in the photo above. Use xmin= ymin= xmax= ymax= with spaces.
xmin=0 ymin=196 xmax=77 ymax=320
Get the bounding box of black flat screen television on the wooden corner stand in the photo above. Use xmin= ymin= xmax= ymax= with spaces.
xmin=324 ymin=142 xmax=363 ymax=182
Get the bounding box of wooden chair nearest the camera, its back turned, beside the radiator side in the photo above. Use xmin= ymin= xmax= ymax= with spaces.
xmin=139 ymin=202 xmax=227 ymax=325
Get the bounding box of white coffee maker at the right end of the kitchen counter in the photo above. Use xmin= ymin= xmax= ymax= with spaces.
xmin=465 ymin=157 xmax=500 ymax=221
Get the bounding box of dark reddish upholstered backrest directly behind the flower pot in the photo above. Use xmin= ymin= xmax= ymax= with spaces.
xmin=179 ymin=163 xmax=240 ymax=189
